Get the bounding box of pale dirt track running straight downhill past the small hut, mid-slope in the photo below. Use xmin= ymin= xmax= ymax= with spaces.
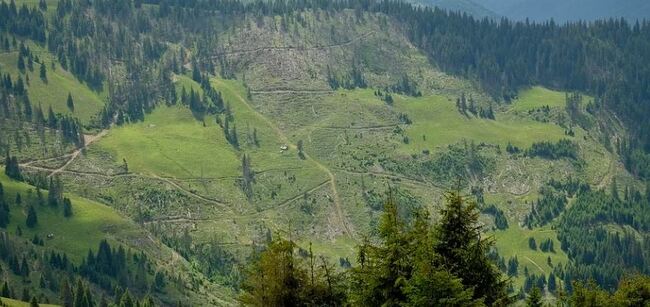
xmin=215 ymin=80 xmax=354 ymax=239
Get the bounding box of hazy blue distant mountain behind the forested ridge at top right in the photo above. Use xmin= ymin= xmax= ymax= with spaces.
xmin=470 ymin=0 xmax=650 ymax=22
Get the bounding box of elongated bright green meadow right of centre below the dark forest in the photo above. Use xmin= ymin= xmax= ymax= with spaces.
xmin=395 ymin=92 xmax=564 ymax=152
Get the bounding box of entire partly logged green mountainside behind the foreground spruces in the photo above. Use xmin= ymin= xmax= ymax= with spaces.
xmin=0 ymin=0 xmax=650 ymax=305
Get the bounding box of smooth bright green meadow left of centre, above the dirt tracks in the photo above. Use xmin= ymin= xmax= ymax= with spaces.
xmin=97 ymin=106 xmax=240 ymax=178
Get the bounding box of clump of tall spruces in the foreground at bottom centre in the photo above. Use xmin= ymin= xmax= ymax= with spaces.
xmin=241 ymin=193 xmax=511 ymax=306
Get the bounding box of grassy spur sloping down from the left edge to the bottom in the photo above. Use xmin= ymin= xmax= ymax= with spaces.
xmin=0 ymin=173 xmax=233 ymax=305
